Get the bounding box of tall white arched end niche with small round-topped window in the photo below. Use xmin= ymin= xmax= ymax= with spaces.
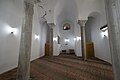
xmin=54 ymin=0 xmax=80 ymax=56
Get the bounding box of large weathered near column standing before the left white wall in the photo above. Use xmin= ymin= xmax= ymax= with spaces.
xmin=16 ymin=1 xmax=34 ymax=80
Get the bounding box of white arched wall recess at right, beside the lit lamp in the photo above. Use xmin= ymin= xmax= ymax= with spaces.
xmin=86 ymin=12 xmax=111 ymax=63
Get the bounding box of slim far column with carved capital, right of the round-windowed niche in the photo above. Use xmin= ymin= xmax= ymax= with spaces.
xmin=78 ymin=20 xmax=87 ymax=60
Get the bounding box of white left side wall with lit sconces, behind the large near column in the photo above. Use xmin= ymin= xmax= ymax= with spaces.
xmin=0 ymin=0 xmax=43 ymax=74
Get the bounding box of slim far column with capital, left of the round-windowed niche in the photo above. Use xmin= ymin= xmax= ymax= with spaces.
xmin=48 ymin=23 xmax=55 ymax=56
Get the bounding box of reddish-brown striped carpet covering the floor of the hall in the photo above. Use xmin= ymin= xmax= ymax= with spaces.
xmin=0 ymin=55 xmax=113 ymax=80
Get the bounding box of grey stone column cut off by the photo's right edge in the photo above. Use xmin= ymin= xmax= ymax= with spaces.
xmin=105 ymin=0 xmax=120 ymax=80
